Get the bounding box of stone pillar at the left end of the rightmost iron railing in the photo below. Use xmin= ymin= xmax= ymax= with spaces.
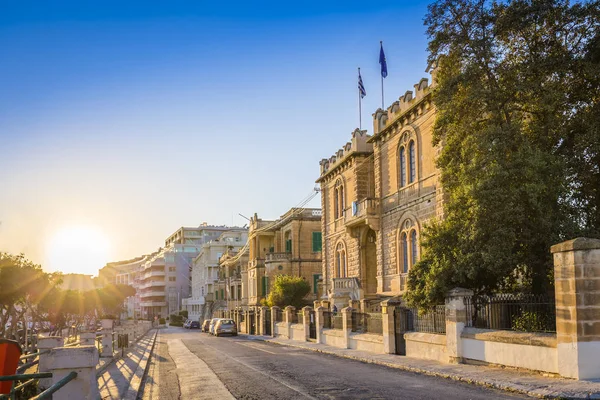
xmin=446 ymin=288 xmax=473 ymax=364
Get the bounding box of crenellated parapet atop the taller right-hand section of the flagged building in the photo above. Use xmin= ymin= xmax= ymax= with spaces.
xmin=371 ymin=62 xmax=437 ymax=141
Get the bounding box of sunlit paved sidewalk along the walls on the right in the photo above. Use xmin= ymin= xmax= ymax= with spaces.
xmin=242 ymin=334 xmax=600 ymax=399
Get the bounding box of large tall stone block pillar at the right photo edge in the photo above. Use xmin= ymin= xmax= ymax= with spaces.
xmin=551 ymin=238 xmax=600 ymax=379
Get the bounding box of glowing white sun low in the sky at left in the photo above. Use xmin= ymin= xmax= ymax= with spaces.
xmin=46 ymin=226 xmax=110 ymax=275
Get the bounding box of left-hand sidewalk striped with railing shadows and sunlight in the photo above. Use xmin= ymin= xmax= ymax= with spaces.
xmin=96 ymin=329 xmax=158 ymax=400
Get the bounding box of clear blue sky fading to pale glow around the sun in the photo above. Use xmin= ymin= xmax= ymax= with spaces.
xmin=0 ymin=0 xmax=428 ymax=274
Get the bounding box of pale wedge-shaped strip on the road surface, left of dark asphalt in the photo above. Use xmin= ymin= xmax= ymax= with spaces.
xmin=167 ymin=339 xmax=235 ymax=400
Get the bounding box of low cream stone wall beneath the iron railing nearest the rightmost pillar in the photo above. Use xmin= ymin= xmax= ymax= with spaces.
xmin=461 ymin=328 xmax=558 ymax=373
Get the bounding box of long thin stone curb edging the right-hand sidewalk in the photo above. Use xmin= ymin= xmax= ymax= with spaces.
xmin=244 ymin=335 xmax=600 ymax=400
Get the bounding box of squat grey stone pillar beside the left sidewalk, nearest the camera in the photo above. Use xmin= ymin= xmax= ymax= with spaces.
xmin=49 ymin=346 xmax=100 ymax=400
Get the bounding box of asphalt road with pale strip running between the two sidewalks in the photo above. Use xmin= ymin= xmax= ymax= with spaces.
xmin=142 ymin=328 xmax=527 ymax=400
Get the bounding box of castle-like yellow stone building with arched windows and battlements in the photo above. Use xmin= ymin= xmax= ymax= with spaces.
xmin=317 ymin=66 xmax=443 ymax=309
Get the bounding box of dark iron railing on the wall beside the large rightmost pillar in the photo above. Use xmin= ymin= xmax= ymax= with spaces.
xmin=465 ymin=293 xmax=556 ymax=332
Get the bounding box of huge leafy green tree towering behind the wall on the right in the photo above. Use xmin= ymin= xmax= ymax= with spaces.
xmin=407 ymin=0 xmax=600 ymax=307
